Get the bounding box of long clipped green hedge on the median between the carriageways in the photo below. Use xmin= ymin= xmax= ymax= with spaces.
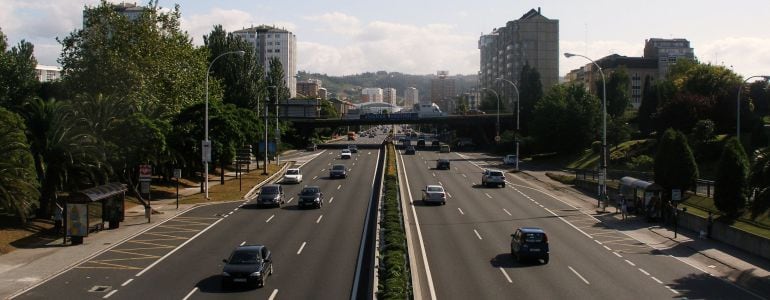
xmin=377 ymin=144 xmax=412 ymax=299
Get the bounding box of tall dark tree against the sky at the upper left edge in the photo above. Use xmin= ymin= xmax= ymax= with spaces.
xmin=0 ymin=30 xmax=39 ymax=111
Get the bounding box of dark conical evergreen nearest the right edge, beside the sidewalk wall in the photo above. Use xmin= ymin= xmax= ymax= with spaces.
xmin=714 ymin=137 xmax=749 ymax=217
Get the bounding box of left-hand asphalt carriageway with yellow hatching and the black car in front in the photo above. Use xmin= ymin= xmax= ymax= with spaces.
xmin=18 ymin=135 xmax=384 ymax=299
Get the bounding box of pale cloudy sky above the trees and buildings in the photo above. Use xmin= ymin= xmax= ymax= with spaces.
xmin=0 ymin=0 xmax=770 ymax=78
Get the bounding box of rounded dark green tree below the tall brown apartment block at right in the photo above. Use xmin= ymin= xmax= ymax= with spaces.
xmin=532 ymin=84 xmax=601 ymax=153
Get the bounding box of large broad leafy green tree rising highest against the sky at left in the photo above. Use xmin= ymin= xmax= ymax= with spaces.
xmin=59 ymin=0 xmax=209 ymax=118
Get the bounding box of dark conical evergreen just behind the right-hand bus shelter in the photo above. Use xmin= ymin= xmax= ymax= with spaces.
xmin=654 ymin=129 xmax=698 ymax=193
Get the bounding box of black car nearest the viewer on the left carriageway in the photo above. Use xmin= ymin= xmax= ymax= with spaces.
xmin=222 ymin=245 xmax=273 ymax=287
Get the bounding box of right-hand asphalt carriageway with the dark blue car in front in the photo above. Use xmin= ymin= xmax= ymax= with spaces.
xmin=399 ymin=145 xmax=756 ymax=299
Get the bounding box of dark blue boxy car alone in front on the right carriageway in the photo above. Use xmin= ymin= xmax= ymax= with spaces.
xmin=511 ymin=227 xmax=550 ymax=264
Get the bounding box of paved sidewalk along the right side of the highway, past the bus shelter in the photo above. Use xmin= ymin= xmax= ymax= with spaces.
xmin=516 ymin=170 xmax=770 ymax=298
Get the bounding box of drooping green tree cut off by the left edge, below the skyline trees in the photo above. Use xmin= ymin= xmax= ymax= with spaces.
xmin=0 ymin=107 xmax=40 ymax=224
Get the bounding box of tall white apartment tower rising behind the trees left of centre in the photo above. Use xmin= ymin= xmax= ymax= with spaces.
xmin=233 ymin=25 xmax=297 ymax=98
